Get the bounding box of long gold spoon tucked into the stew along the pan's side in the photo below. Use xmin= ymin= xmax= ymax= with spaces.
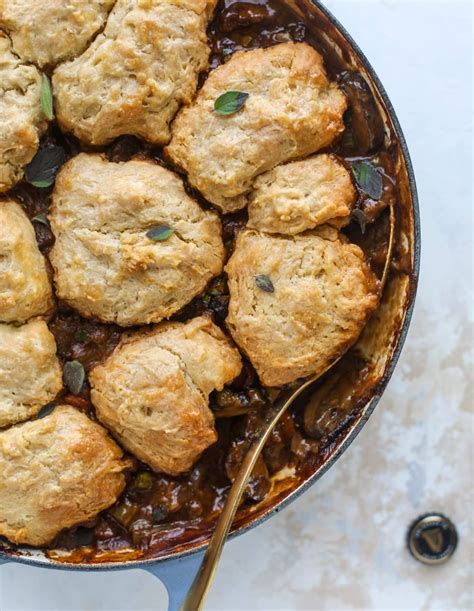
xmin=181 ymin=201 xmax=395 ymax=611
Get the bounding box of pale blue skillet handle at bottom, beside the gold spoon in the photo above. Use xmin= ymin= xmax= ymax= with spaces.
xmin=144 ymin=552 xmax=204 ymax=611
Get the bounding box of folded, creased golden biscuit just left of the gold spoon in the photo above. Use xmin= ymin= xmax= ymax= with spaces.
xmin=89 ymin=317 xmax=242 ymax=475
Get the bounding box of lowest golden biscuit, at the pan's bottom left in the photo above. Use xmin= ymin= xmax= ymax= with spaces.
xmin=0 ymin=405 xmax=129 ymax=545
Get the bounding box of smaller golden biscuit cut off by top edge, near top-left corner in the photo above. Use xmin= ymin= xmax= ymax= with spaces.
xmin=0 ymin=0 xmax=115 ymax=66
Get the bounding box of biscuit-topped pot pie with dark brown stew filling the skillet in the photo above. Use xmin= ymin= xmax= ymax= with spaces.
xmin=0 ymin=0 xmax=395 ymax=561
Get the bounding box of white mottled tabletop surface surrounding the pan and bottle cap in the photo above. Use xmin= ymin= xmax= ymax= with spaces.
xmin=0 ymin=0 xmax=474 ymax=611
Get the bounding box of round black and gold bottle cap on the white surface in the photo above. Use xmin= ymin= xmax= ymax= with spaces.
xmin=407 ymin=513 xmax=458 ymax=564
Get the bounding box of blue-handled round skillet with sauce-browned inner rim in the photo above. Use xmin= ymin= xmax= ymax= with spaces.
xmin=0 ymin=0 xmax=420 ymax=609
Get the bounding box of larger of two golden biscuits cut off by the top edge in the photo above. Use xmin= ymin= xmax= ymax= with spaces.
xmin=53 ymin=0 xmax=216 ymax=144
